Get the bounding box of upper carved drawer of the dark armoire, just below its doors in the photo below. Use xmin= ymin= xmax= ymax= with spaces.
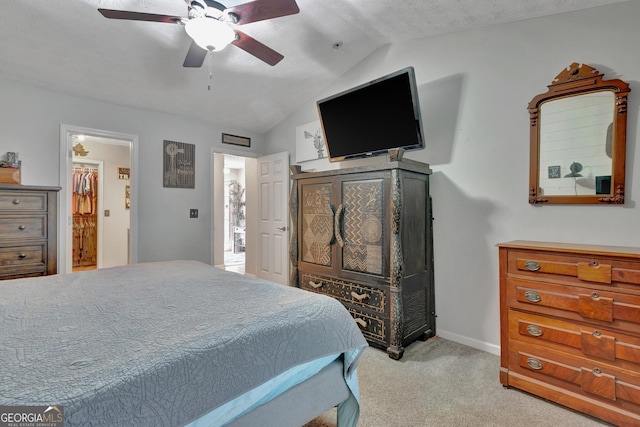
xmin=300 ymin=272 xmax=387 ymax=314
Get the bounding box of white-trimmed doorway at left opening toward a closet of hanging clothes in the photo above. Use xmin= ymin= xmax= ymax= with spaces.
xmin=58 ymin=125 xmax=137 ymax=273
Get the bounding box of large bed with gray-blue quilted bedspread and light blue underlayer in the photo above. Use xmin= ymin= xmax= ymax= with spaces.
xmin=0 ymin=261 xmax=367 ymax=427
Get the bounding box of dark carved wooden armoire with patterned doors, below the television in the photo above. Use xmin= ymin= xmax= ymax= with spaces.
xmin=290 ymin=160 xmax=435 ymax=359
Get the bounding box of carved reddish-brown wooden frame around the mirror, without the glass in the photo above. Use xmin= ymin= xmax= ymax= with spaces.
xmin=528 ymin=62 xmax=631 ymax=205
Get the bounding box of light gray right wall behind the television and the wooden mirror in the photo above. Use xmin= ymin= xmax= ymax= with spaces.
xmin=266 ymin=2 xmax=640 ymax=352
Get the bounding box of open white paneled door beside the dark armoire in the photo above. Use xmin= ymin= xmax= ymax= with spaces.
xmin=257 ymin=152 xmax=289 ymax=285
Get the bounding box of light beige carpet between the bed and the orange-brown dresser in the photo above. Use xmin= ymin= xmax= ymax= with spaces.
xmin=305 ymin=337 xmax=609 ymax=427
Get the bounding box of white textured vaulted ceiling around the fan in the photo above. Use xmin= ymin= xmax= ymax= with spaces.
xmin=0 ymin=0 xmax=632 ymax=133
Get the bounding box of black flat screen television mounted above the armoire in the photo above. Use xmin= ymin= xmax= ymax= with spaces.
xmin=317 ymin=67 xmax=424 ymax=162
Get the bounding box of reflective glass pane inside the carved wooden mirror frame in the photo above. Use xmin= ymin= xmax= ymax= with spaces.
xmin=539 ymin=91 xmax=614 ymax=196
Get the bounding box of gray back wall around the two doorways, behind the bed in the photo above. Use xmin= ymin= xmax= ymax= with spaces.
xmin=0 ymin=78 xmax=263 ymax=263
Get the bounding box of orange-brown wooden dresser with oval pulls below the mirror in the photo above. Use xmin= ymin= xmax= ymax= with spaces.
xmin=498 ymin=241 xmax=640 ymax=426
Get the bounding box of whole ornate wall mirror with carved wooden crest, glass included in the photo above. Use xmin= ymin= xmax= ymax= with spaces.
xmin=529 ymin=62 xmax=630 ymax=204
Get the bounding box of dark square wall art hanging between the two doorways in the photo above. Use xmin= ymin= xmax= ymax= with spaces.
xmin=162 ymin=140 xmax=196 ymax=188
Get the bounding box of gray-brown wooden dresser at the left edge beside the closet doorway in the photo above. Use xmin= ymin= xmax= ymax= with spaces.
xmin=0 ymin=185 xmax=60 ymax=279
